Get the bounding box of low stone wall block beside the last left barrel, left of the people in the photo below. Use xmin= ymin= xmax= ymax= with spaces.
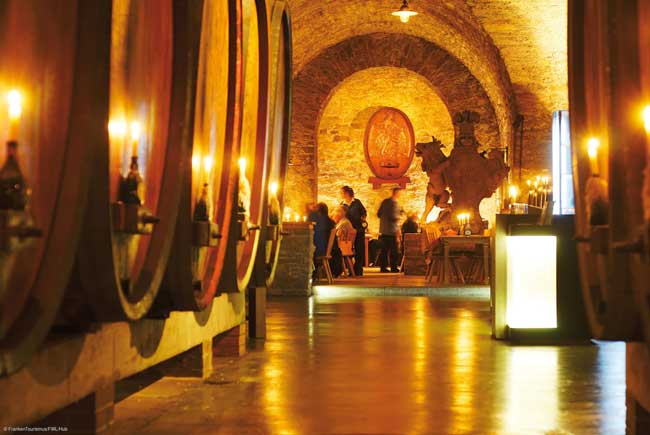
xmin=269 ymin=222 xmax=314 ymax=296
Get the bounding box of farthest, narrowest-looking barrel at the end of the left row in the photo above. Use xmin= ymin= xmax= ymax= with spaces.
xmin=254 ymin=1 xmax=292 ymax=287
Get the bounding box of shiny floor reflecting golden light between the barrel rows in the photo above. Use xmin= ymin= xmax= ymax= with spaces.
xmin=115 ymin=297 xmax=625 ymax=435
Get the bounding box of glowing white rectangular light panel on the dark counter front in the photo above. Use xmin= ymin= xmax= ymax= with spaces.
xmin=506 ymin=236 xmax=557 ymax=329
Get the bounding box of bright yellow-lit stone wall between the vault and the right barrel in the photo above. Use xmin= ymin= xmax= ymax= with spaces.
xmin=467 ymin=0 xmax=569 ymax=181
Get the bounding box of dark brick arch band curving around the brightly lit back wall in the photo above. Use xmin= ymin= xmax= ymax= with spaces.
xmin=285 ymin=33 xmax=510 ymax=209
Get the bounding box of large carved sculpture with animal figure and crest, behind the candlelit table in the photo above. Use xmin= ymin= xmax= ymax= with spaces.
xmin=416 ymin=111 xmax=510 ymax=233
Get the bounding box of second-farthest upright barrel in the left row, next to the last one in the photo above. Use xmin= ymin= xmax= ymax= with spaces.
xmin=219 ymin=0 xmax=270 ymax=292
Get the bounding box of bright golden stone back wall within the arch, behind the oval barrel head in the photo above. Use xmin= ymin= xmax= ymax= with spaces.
xmin=318 ymin=67 xmax=454 ymax=232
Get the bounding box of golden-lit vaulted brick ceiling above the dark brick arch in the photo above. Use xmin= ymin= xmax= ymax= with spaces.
xmin=289 ymin=0 xmax=515 ymax=145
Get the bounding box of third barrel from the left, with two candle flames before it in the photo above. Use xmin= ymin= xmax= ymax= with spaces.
xmin=160 ymin=0 xmax=243 ymax=310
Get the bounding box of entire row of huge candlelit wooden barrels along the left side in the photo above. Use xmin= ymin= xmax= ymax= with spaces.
xmin=0 ymin=0 xmax=291 ymax=375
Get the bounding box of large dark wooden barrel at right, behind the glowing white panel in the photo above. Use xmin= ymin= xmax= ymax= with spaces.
xmin=569 ymin=0 xmax=650 ymax=341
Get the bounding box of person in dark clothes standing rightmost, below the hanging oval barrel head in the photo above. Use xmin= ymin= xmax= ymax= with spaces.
xmin=377 ymin=187 xmax=402 ymax=272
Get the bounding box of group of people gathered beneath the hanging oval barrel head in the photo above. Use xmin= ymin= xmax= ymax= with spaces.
xmin=308 ymin=186 xmax=418 ymax=277
